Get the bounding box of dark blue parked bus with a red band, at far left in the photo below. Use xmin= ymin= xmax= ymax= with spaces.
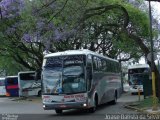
xmin=5 ymin=76 xmax=19 ymax=97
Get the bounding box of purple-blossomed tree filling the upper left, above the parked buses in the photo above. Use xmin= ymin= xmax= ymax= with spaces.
xmin=0 ymin=0 xmax=76 ymax=70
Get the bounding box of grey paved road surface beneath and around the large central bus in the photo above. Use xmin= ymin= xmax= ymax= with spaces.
xmin=0 ymin=93 xmax=143 ymax=120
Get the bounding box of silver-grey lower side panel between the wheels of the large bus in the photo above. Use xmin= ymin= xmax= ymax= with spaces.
xmin=90 ymin=72 xmax=122 ymax=104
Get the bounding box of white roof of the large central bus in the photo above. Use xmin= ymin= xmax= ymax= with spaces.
xmin=44 ymin=49 xmax=118 ymax=62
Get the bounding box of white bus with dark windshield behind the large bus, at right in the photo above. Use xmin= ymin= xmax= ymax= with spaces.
xmin=128 ymin=64 xmax=151 ymax=94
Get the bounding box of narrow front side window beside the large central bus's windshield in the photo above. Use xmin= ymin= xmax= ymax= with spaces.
xmin=86 ymin=55 xmax=92 ymax=90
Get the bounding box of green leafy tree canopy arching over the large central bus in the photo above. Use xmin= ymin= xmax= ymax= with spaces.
xmin=0 ymin=0 xmax=156 ymax=73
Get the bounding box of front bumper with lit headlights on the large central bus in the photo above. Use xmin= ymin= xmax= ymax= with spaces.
xmin=43 ymin=102 xmax=89 ymax=110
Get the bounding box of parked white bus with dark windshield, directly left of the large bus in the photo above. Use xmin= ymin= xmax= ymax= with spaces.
xmin=18 ymin=71 xmax=41 ymax=97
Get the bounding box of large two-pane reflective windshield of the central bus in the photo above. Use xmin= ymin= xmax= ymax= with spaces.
xmin=42 ymin=55 xmax=86 ymax=94
